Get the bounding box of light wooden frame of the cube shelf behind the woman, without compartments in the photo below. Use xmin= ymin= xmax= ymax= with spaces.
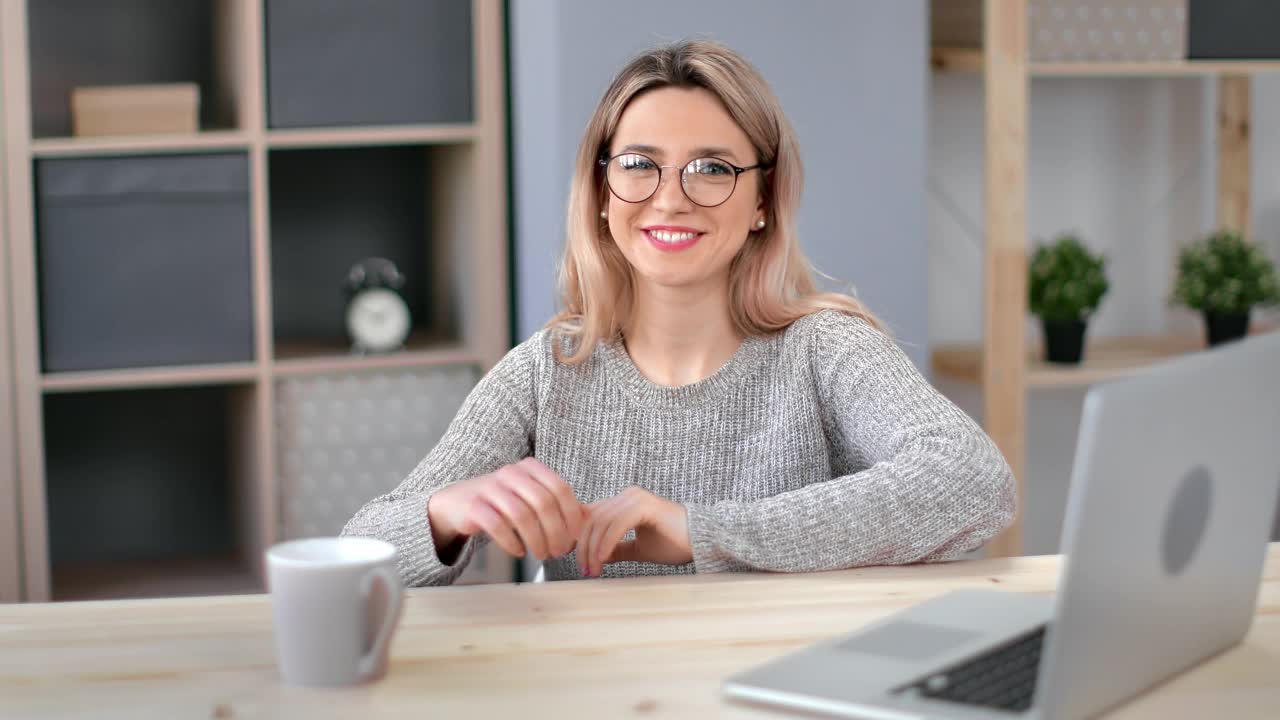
xmin=0 ymin=0 xmax=509 ymax=602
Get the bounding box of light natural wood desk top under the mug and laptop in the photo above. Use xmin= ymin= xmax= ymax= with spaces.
xmin=0 ymin=544 xmax=1280 ymax=720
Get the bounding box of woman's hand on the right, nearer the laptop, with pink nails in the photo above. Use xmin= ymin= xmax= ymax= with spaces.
xmin=577 ymin=487 xmax=694 ymax=578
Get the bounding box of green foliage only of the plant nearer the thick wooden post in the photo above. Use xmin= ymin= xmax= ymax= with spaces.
xmin=1028 ymin=233 xmax=1110 ymax=323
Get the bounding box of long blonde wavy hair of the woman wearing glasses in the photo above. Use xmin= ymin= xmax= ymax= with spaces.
xmin=547 ymin=40 xmax=883 ymax=365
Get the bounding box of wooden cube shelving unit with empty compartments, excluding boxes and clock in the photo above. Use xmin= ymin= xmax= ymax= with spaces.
xmin=0 ymin=0 xmax=512 ymax=601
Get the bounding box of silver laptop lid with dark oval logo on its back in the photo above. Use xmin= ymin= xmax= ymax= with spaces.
xmin=1036 ymin=333 xmax=1280 ymax=720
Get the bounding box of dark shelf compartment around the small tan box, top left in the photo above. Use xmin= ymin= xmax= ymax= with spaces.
xmin=27 ymin=0 xmax=246 ymax=138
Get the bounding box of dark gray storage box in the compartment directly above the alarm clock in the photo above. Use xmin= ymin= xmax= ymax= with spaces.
xmin=266 ymin=0 xmax=472 ymax=128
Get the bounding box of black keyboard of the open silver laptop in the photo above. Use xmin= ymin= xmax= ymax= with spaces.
xmin=897 ymin=626 xmax=1046 ymax=712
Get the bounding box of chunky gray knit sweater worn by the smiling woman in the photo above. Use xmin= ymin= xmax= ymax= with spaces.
xmin=343 ymin=310 xmax=1015 ymax=585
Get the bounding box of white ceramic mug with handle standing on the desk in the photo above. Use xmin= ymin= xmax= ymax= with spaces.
xmin=259 ymin=537 xmax=404 ymax=685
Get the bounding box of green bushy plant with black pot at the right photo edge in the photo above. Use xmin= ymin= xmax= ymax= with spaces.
xmin=1172 ymin=229 xmax=1280 ymax=346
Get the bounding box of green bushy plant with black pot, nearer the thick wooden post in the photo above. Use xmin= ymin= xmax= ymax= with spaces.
xmin=1028 ymin=233 xmax=1110 ymax=364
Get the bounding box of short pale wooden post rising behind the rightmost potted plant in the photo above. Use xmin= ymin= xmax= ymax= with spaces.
xmin=1217 ymin=76 xmax=1251 ymax=237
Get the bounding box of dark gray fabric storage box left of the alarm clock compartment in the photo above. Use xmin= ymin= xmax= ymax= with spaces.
xmin=36 ymin=154 xmax=253 ymax=372
